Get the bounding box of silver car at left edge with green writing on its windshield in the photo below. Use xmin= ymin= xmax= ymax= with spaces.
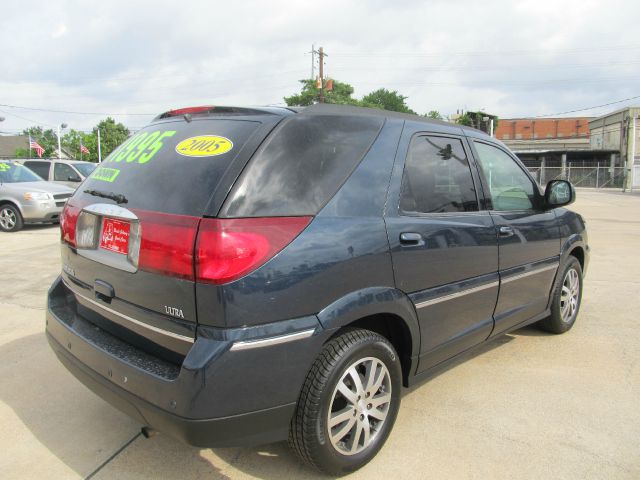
xmin=0 ymin=161 xmax=74 ymax=232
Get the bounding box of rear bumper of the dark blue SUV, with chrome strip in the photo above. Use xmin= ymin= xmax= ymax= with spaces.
xmin=47 ymin=278 xmax=329 ymax=447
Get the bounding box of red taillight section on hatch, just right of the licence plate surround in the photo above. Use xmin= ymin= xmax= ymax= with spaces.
xmin=134 ymin=210 xmax=200 ymax=280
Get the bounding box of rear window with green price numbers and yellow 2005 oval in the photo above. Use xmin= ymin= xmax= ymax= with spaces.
xmin=75 ymin=119 xmax=261 ymax=216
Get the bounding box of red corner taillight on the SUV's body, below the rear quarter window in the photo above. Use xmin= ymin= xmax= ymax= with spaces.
xmin=196 ymin=217 xmax=311 ymax=284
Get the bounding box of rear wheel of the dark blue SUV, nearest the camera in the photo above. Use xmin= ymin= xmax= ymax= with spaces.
xmin=289 ymin=329 xmax=402 ymax=476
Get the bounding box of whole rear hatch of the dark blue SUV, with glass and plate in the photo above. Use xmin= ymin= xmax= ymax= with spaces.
xmin=61 ymin=113 xmax=281 ymax=356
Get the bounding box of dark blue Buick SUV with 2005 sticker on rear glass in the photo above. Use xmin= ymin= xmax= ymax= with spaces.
xmin=47 ymin=105 xmax=589 ymax=475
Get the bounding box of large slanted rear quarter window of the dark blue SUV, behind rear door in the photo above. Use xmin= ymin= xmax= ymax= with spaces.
xmin=222 ymin=114 xmax=383 ymax=217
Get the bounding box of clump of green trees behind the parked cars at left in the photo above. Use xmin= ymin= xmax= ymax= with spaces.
xmin=16 ymin=117 xmax=130 ymax=162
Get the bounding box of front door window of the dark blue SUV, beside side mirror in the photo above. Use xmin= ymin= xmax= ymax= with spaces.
xmin=475 ymin=142 xmax=537 ymax=211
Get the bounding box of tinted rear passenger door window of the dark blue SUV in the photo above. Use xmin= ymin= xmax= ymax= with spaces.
xmin=400 ymin=136 xmax=478 ymax=213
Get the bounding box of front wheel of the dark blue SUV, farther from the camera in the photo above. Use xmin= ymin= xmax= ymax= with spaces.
xmin=539 ymin=256 xmax=582 ymax=334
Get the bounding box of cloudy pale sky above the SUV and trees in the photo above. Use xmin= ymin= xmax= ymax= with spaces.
xmin=0 ymin=0 xmax=640 ymax=133
